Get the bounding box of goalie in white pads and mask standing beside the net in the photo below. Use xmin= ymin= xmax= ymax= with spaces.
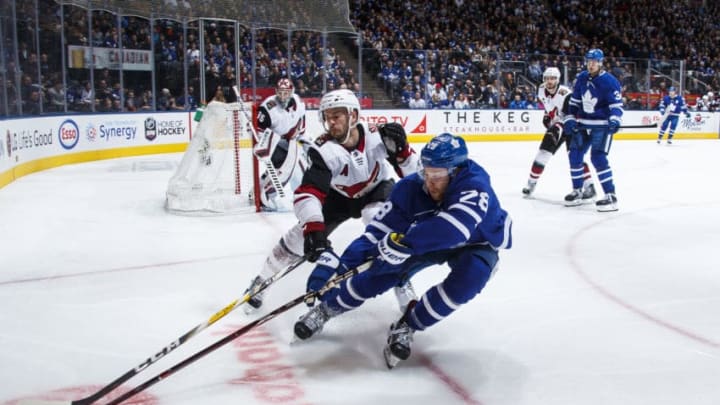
xmin=253 ymin=79 xmax=307 ymax=210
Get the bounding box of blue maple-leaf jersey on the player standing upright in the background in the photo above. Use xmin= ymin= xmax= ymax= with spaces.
xmin=566 ymin=70 xmax=623 ymax=126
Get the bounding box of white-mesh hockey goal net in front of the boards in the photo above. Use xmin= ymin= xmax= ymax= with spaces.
xmin=166 ymin=101 xmax=260 ymax=214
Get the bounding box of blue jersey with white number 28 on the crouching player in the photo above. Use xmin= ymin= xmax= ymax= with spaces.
xmin=342 ymin=160 xmax=512 ymax=267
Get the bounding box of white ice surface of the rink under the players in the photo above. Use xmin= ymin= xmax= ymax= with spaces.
xmin=0 ymin=140 xmax=720 ymax=405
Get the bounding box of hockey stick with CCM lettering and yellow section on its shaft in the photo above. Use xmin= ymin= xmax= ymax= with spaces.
xmin=19 ymin=257 xmax=305 ymax=405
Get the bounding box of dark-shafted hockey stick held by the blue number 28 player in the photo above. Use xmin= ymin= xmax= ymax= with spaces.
xmin=105 ymin=260 xmax=372 ymax=405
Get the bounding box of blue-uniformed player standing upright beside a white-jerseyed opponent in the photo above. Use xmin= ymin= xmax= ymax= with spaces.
xmin=564 ymin=49 xmax=623 ymax=211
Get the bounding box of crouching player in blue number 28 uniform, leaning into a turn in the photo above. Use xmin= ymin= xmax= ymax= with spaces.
xmin=295 ymin=133 xmax=512 ymax=368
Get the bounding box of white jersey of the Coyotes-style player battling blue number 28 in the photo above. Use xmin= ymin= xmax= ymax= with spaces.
xmin=294 ymin=122 xmax=418 ymax=224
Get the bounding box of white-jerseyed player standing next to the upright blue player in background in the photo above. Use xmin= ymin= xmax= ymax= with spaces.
xmin=522 ymin=67 xmax=595 ymax=200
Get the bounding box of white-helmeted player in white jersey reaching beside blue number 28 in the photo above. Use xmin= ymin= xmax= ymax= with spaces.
xmin=246 ymin=90 xmax=418 ymax=312
